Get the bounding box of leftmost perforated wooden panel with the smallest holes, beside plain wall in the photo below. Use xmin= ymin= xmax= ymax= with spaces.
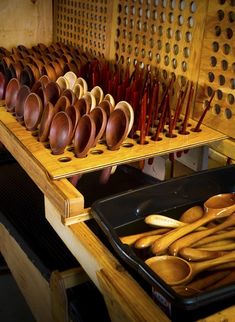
xmin=54 ymin=0 xmax=115 ymax=58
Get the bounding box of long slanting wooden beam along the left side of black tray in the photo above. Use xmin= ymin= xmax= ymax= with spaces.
xmin=45 ymin=198 xmax=169 ymax=322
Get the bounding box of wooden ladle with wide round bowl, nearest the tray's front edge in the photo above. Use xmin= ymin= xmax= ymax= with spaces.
xmin=145 ymin=252 xmax=235 ymax=285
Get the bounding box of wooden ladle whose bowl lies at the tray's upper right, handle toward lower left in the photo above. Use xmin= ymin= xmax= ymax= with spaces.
xmin=152 ymin=193 xmax=235 ymax=254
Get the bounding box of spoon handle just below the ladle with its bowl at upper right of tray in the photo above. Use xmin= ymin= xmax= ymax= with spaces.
xmin=169 ymin=213 xmax=235 ymax=255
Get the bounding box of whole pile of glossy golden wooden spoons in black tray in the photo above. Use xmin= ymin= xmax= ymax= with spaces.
xmin=121 ymin=193 xmax=235 ymax=295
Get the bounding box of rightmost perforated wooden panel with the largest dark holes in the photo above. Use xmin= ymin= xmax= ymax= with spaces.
xmin=194 ymin=0 xmax=235 ymax=137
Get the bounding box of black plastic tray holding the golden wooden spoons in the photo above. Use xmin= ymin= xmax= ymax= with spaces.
xmin=92 ymin=165 xmax=235 ymax=321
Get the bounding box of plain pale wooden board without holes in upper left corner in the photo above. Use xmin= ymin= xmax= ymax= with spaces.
xmin=0 ymin=0 xmax=52 ymax=50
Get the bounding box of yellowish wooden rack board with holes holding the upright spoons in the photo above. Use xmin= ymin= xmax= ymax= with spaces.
xmin=0 ymin=107 xmax=226 ymax=179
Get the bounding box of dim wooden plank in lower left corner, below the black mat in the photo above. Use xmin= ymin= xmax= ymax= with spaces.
xmin=0 ymin=224 xmax=53 ymax=322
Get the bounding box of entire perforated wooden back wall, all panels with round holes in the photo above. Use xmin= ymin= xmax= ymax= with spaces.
xmin=54 ymin=0 xmax=235 ymax=137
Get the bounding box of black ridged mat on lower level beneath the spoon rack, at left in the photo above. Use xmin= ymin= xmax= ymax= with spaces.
xmin=0 ymin=162 xmax=78 ymax=272
